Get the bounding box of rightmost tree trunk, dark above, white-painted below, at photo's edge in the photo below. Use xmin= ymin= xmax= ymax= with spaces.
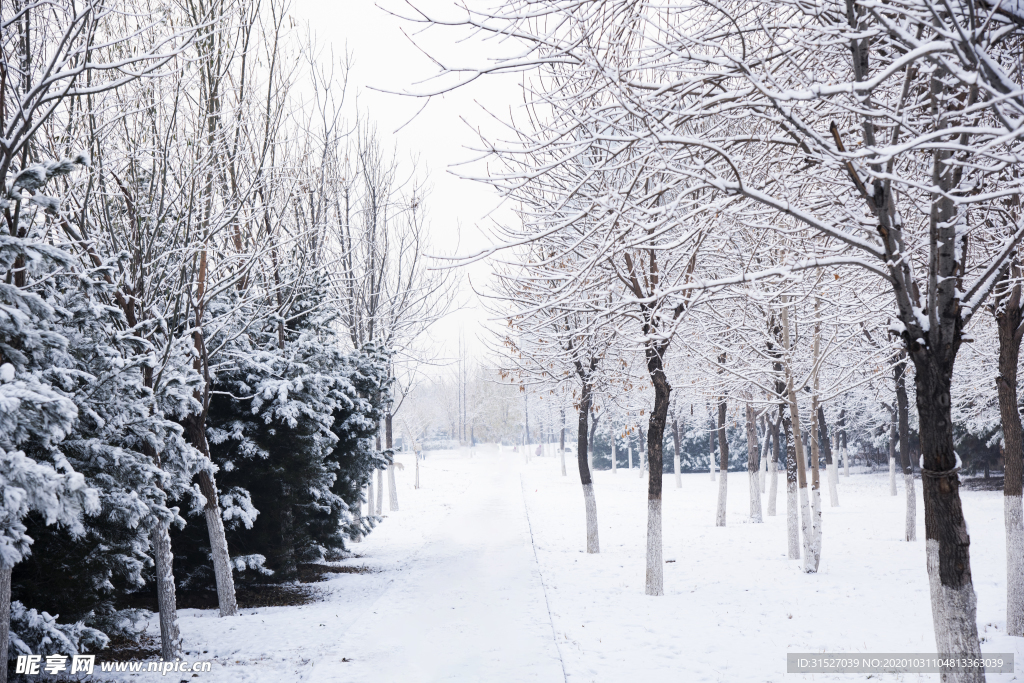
xmin=995 ymin=263 xmax=1024 ymax=636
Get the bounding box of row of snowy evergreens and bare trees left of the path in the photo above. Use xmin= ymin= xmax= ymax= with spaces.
xmin=0 ymin=0 xmax=455 ymax=680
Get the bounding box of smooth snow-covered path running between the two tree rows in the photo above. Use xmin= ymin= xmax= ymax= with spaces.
xmin=310 ymin=454 xmax=564 ymax=683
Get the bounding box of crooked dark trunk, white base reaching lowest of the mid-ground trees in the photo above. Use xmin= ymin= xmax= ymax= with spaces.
xmin=644 ymin=346 xmax=672 ymax=595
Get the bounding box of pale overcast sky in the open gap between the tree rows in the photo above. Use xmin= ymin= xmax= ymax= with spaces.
xmin=292 ymin=0 xmax=520 ymax=374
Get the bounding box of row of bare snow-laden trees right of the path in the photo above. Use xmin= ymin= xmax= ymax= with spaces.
xmin=411 ymin=0 xmax=1024 ymax=680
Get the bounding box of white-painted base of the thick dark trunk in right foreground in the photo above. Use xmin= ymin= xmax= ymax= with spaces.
xmin=925 ymin=539 xmax=985 ymax=683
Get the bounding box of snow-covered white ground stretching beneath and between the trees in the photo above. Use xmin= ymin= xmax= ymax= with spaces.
xmin=114 ymin=446 xmax=1024 ymax=683
